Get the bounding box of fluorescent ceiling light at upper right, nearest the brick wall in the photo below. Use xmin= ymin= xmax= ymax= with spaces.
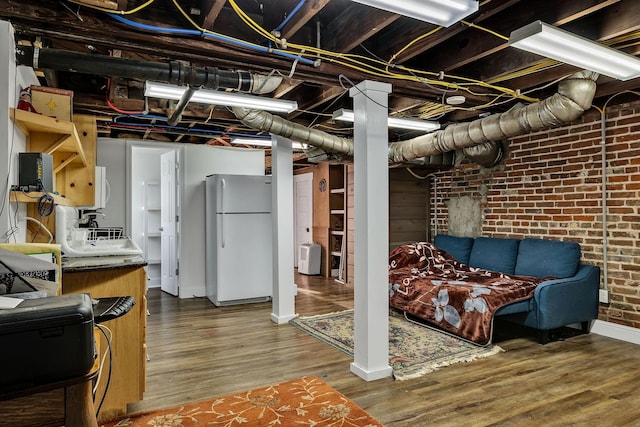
xmin=509 ymin=21 xmax=640 ymax=80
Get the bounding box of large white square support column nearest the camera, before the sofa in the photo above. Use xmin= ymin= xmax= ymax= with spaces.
xmin=349 ymin=81 xmax=392 ymax=381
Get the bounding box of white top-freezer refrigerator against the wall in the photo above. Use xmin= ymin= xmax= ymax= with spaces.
xmin=205 ymin=175 xmax=273 ymax=306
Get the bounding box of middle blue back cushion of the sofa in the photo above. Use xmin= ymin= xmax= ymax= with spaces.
xmin=469 ymin=237 xmax=520 ymax=274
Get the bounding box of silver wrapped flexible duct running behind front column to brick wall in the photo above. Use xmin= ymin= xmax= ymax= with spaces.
xmin=233 ymin=71 xmax=598 ymax=164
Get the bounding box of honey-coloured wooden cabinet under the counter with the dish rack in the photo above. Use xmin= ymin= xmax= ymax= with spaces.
xmin=62 ymin=265 xmax=147 ymax=420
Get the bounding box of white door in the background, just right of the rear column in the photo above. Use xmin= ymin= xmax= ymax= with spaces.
xmin=293 ymin=173 xmax=313 ymax=267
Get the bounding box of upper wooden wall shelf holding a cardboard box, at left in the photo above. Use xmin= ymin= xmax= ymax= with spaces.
xmin=10 ymin=108 xmax=87 ymax=173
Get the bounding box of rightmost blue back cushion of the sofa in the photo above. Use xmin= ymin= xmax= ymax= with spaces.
xmin=515 ymin=239 xmax=580 ymax=278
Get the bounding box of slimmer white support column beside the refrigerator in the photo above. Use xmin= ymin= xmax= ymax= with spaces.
xmin=271 ymin=135 xmax=297 ymax=324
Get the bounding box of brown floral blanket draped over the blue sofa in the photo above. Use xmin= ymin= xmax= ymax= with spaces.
xmin=389 ymin=242 xmax=550 ymax=345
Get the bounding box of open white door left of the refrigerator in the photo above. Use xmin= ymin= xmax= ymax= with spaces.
xmin=160 ymin=151 xmax=178 ymax=296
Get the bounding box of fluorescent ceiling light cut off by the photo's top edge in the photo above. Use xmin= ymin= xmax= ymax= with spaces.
xmin=353 ymin=0 xmax=478 ymax=27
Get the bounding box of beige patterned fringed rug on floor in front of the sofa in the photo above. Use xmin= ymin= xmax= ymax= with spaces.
xmin=289 ymin=310 xmax=503 ymax=380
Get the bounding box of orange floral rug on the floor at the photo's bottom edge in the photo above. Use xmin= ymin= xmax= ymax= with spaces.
xmin=100 ymin=376 xmax=382 ymax=427
